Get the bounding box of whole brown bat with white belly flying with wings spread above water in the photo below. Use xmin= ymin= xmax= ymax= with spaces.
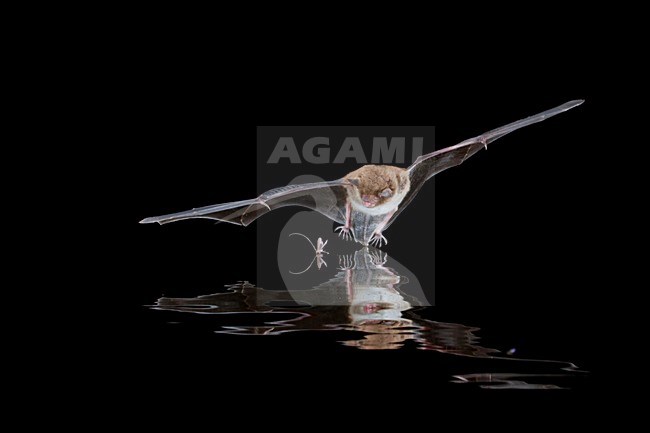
xmin=140 ymin=100 xmax=584 ymax=248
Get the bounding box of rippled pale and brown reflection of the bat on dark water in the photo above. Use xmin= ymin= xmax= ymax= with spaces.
xmin=152 ymin=248 xmax=578 ymax=389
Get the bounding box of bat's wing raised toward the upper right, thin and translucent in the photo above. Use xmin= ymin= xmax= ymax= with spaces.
xmin=386 ymin=99 xmax=584 ymax=228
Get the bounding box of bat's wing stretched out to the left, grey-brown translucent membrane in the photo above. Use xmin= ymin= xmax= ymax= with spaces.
xmin=140 ymin=179 xmax=350 ymax=226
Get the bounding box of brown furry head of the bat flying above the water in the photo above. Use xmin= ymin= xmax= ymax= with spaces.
xmin=345 ymin=165 xmax=409 ymax=209
